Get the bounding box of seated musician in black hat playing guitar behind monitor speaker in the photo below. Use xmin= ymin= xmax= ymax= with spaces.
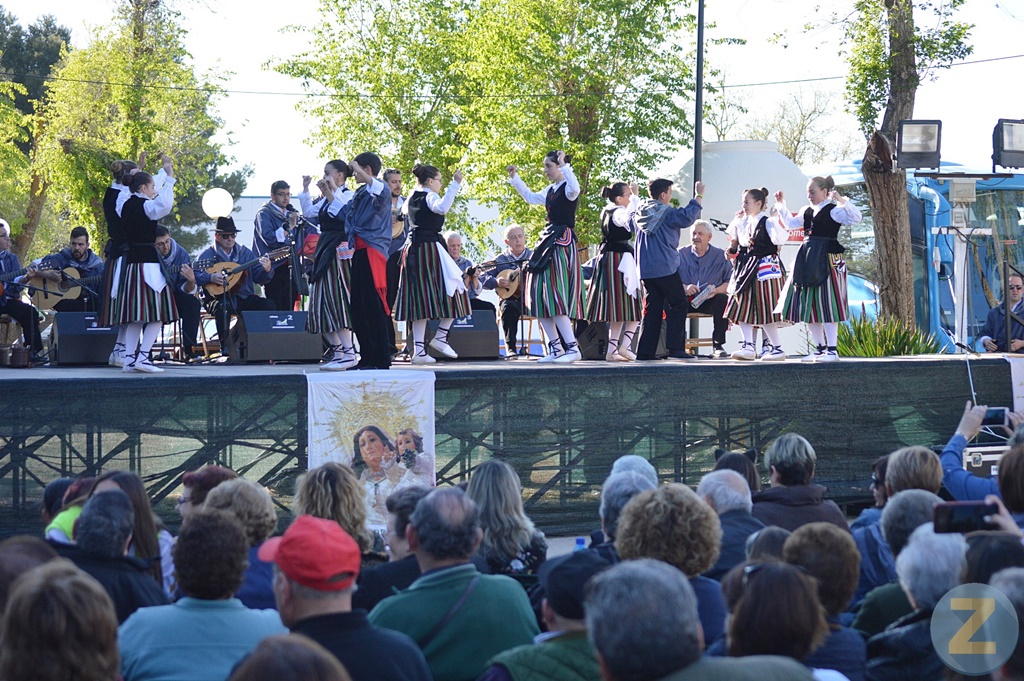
xmin=195 ymin=217 xmax=278 ymax=356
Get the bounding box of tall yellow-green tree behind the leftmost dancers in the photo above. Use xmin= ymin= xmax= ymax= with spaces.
xmin=15 ymin=0 xmax=239 ymax=256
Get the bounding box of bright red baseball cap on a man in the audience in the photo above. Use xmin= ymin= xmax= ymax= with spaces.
xmin=259 ymin=515 xmax=361 ymax=591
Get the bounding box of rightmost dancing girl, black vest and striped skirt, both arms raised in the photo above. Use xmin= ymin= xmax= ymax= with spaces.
xmin=775 ymin=175 xmax=860 ymax=361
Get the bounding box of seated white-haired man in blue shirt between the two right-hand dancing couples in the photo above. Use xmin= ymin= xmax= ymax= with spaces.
xmin=679 ymin=220 xmax=732 ymax=357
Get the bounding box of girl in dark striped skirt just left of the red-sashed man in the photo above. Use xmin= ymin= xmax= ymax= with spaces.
xmin=306 ymin=160 xmax=358 ymax=372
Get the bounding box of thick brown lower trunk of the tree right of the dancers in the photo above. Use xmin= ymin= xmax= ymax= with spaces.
xmin=860 ymin=132 xmax=916 ymax=325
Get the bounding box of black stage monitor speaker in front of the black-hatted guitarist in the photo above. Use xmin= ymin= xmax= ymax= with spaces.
xmin=231 ymin=311 xmax=324 ymax=363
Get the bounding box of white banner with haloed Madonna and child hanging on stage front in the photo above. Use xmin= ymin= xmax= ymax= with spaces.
xmin=306 ymin=370 xmax=436 ymax=529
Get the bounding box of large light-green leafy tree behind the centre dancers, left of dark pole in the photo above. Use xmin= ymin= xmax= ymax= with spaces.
xmin=275 ymin=0 xmax=694 ymax=248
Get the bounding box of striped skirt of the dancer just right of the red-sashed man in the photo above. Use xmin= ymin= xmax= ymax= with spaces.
xmin=394 ymin=242 xmax=470 ymax=322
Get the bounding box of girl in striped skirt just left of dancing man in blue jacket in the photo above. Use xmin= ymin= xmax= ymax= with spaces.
xmin=587 ymin=182 xmax=640 ymax=361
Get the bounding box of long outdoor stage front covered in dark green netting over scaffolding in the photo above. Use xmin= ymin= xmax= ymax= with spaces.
xmin=0 ymin=355 xmax=1013 ymax=536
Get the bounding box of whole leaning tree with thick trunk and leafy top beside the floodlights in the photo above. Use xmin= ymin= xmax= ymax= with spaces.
xmin=846 ymin=0 xmax=972 ymax=324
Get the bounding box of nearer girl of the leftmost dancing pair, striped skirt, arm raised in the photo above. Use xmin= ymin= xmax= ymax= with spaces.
xmin=111 ymin=157 xmax=178 ymax=374
